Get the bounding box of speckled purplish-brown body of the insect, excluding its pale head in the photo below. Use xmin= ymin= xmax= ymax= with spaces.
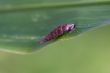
xmin=39 ymin=24 xmax=74 ymax=44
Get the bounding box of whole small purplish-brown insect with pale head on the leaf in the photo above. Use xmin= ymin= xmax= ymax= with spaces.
xmin=39 ymin=24 xmax=75 ymax=44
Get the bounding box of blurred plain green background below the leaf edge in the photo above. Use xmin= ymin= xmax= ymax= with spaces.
xmin=0 ymin=26 xmax=110 ymax=73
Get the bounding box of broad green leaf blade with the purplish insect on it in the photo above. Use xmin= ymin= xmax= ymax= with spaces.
xmin=0 ymin=0 xmax=110 ymax=54
